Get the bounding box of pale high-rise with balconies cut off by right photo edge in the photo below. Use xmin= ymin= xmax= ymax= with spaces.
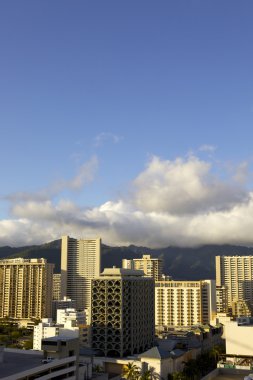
xmin=216 ymin=256 xmax=253 ymax=309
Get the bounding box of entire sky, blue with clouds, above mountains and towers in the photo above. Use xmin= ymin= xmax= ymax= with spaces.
xmin=0 ymin=0 xmax=253 ymax=246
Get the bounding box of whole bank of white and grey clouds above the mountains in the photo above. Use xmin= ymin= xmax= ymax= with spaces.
xmin=0 ymin=156 xmax=253 ymax=247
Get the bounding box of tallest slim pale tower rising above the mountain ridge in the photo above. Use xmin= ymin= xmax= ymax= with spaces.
xmin=61 ymin=236 xmax=101 ymax=310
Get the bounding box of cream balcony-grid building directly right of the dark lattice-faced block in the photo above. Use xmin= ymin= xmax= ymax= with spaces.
xmin=155 ymin=280 xmax=216 ymax=327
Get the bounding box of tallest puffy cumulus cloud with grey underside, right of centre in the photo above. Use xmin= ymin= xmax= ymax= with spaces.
xmin=133 ymin=156 xmax=247 ymax=214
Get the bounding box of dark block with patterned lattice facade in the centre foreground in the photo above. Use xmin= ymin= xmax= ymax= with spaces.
xmin=91 ymin=268 xmax=155 ymax=357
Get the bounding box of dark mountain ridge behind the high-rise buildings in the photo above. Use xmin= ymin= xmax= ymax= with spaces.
xmin=0 ymin=240 xmax=253 ymax=280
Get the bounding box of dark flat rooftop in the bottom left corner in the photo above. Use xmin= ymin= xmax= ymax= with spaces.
xmin=0 ymin=350 xmax=43 ymax=379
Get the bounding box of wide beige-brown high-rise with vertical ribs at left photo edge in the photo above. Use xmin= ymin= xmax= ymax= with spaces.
xmin=0 ymin=258 xmax=54 ymax=320
